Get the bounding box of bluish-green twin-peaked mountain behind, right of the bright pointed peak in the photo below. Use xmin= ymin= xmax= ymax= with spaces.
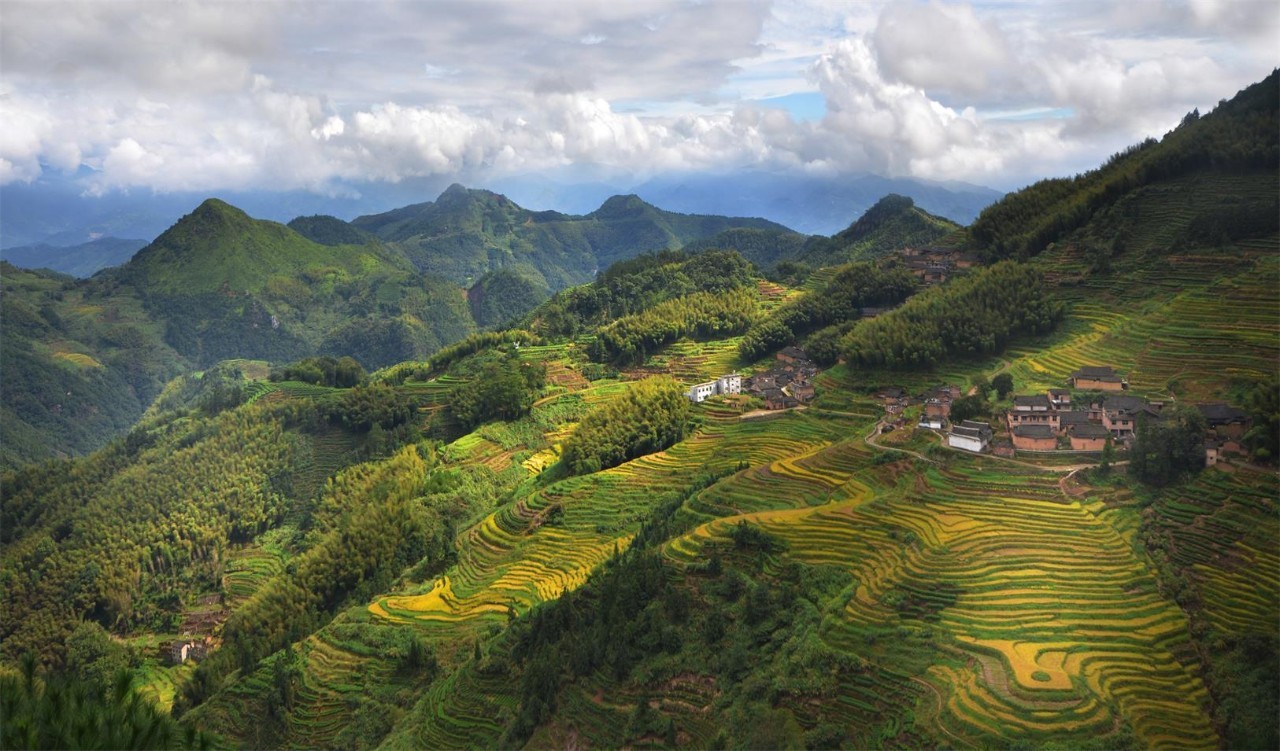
xmin=351 ymin=184 xmax=785 ymax=292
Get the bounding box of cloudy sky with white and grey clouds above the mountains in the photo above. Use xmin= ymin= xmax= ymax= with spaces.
xmin=0 ymin=0 xmax=1280 ymax=196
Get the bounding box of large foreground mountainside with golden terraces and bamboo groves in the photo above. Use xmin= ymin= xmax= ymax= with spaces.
xmin=0 ymin=71 xmax=1280 ymax=748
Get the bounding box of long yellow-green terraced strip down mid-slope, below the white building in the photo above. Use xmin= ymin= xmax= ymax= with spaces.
xmin=370 ymin=404 xmax=836 ymax=640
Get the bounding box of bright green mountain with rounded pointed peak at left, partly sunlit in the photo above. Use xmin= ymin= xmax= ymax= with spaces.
xmin=118 ymin=198 xmax=475 ymax=367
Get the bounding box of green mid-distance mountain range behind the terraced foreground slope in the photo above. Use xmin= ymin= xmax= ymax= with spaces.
xmin=0 ymin=186 xmax=941 ymax=463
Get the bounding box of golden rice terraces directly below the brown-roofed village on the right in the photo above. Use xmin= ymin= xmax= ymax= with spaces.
xmin=667 ymin=460 xmax=1223 ymax=748
